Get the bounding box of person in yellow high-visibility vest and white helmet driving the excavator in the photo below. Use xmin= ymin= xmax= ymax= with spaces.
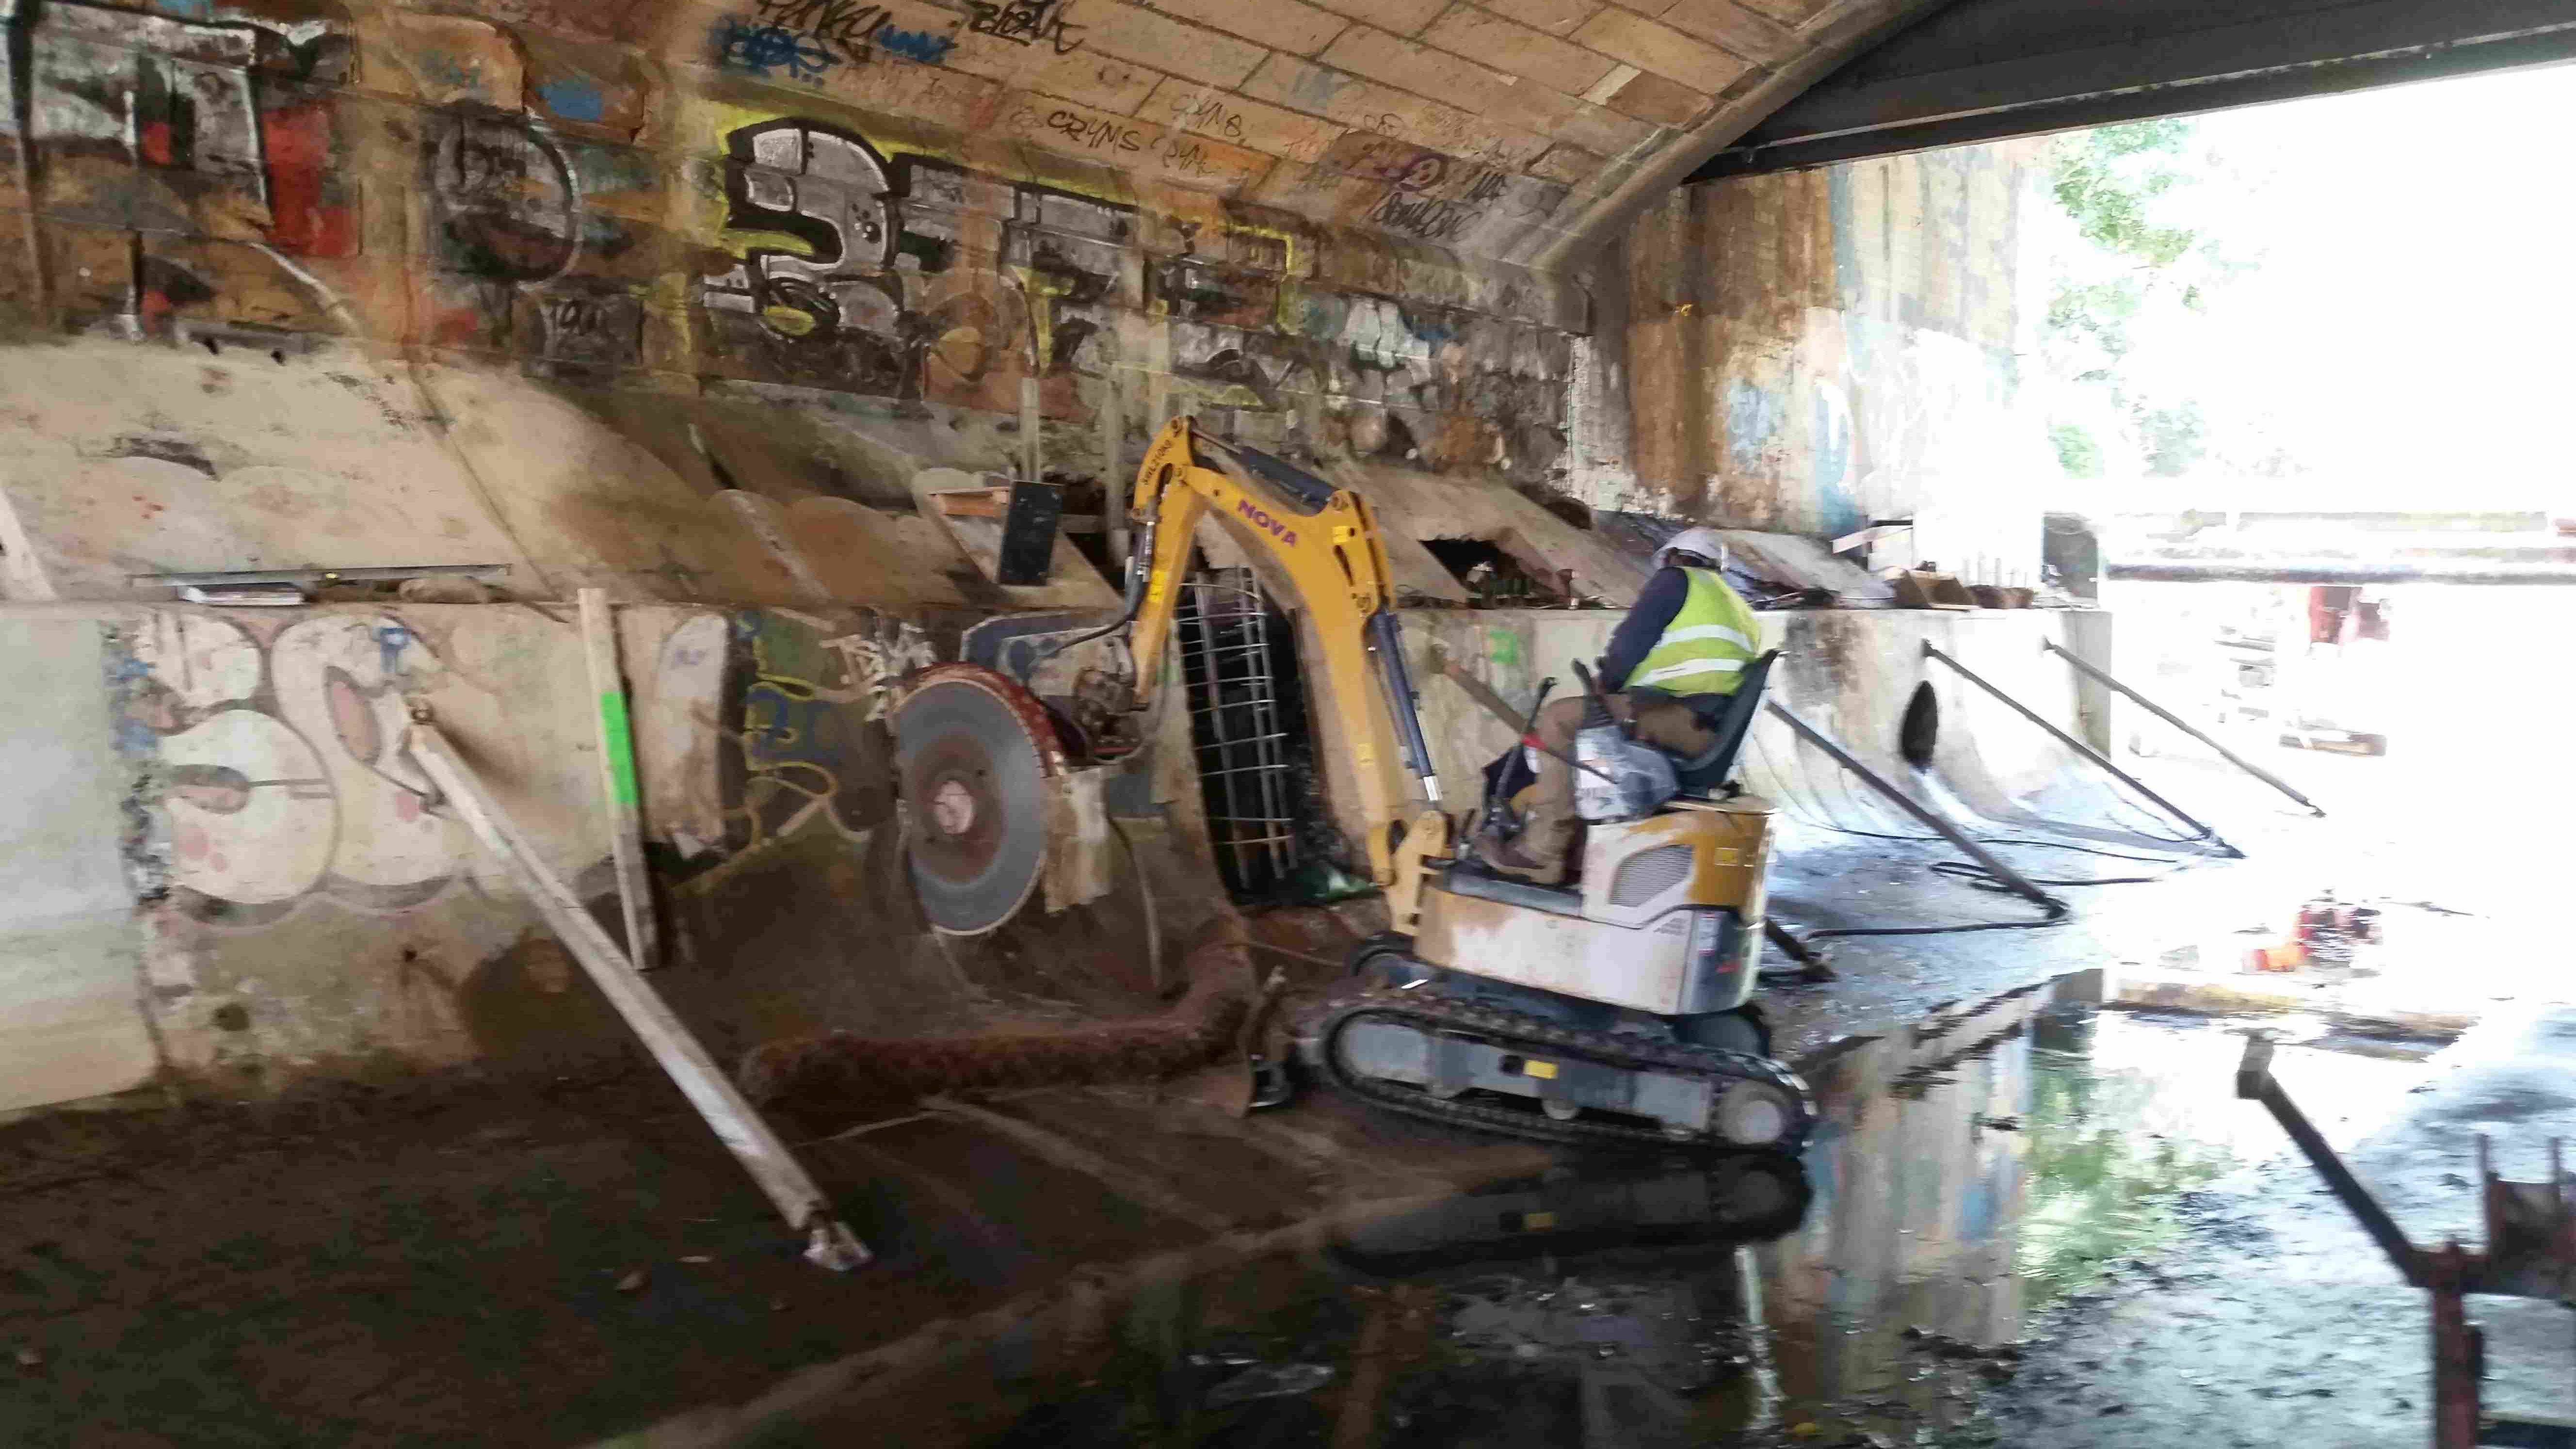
xmin=1479 ymin=529 xmax=1762 ymax=885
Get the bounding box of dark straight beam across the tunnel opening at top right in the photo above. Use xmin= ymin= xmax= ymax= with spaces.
xmin=1687 ymin=0 xmax=2576 ymax=180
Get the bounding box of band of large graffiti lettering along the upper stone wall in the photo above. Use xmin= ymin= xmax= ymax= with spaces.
xmin=0 ymin=0 xmax=1569 ymax=482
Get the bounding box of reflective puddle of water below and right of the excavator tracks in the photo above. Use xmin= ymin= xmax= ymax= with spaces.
xmin=670 ymin=975 xmax=2421 ymax=1449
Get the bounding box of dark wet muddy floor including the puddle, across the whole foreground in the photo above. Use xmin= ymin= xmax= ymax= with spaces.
xmin=0 ymin=975 xmax=2494 ymax=1449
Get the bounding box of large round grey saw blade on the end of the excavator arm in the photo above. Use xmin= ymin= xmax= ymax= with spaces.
xmin=894 ymin=665 xmax=1064 ymax=936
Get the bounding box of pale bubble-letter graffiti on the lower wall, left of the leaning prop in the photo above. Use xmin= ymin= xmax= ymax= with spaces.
xmin=118 ymin=613 xmax=469 ymax=926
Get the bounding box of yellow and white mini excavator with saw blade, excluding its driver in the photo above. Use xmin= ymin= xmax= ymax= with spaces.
xmin=894 ymin=418 xmax=1814 ymax=1147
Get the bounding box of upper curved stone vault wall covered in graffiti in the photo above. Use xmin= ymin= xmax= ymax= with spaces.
xmin=0 ymin=0 xmax=1752 ymax=518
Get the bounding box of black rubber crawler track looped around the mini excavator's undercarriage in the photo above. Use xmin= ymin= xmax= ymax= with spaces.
xmin=1298 ymin=990 xmax=1816 ymax=1153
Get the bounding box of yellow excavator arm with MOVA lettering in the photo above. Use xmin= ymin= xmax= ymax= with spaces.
xmin=1128 ymin=418 xmax=1448 ymax=892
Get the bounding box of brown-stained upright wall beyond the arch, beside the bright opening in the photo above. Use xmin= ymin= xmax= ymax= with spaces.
xmin=1569 ymin=142 xmax=2056 ymax=578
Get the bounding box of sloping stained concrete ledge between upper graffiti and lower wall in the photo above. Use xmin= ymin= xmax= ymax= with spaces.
xmin=0 ymin=338 xmax=1138 ymax=609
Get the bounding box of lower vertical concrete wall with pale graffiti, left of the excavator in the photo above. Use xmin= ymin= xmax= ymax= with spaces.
xmin=0 ymin=593 xmax=1216 ymax=1111
